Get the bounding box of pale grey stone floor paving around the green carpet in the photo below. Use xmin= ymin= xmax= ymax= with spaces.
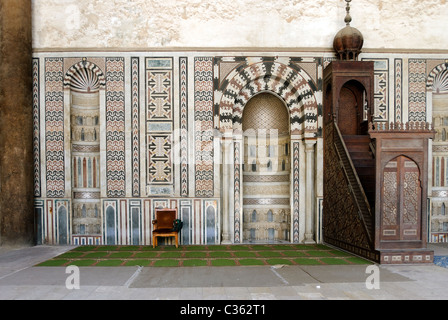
xmin=0 ymin=244 xmax=448 ymax=301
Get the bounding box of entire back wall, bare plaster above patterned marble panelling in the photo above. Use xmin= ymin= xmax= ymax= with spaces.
xmin=32 ymin=0 xmax=448 ymax=245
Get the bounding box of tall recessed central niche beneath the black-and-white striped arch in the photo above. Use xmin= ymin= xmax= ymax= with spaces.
xmin=242 ymin=92 xmax=291 ymax=242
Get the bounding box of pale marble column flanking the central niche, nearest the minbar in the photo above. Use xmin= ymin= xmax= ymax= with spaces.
xmin=303 ymin=140 xmax=316 ymax=243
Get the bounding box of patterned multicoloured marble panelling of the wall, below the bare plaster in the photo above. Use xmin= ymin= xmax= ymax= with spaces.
xmin=33 ymin=51 xmax=448 ymax=244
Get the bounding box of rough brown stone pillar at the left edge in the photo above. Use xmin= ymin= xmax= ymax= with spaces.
xmin=0 ymin=0 xmax=34 ymax=245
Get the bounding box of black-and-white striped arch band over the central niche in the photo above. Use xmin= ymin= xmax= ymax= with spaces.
xmin=218 ymin=61 xmax=321 ymax=137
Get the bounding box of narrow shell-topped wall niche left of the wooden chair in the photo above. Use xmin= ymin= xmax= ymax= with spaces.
xmin=65 ymin=60 xmax=103 ymax=244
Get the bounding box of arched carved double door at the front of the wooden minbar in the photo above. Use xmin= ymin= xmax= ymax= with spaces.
xmin=381 ymin=156 xmax=422 ymax=240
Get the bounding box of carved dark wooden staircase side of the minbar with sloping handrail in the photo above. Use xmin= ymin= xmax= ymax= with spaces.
xmin=323 ymin=121 xmax=379 ymax=262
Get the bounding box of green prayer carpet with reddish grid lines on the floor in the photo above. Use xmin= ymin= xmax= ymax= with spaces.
xmin=36 ymin=244 xmax=372 ymax=267
